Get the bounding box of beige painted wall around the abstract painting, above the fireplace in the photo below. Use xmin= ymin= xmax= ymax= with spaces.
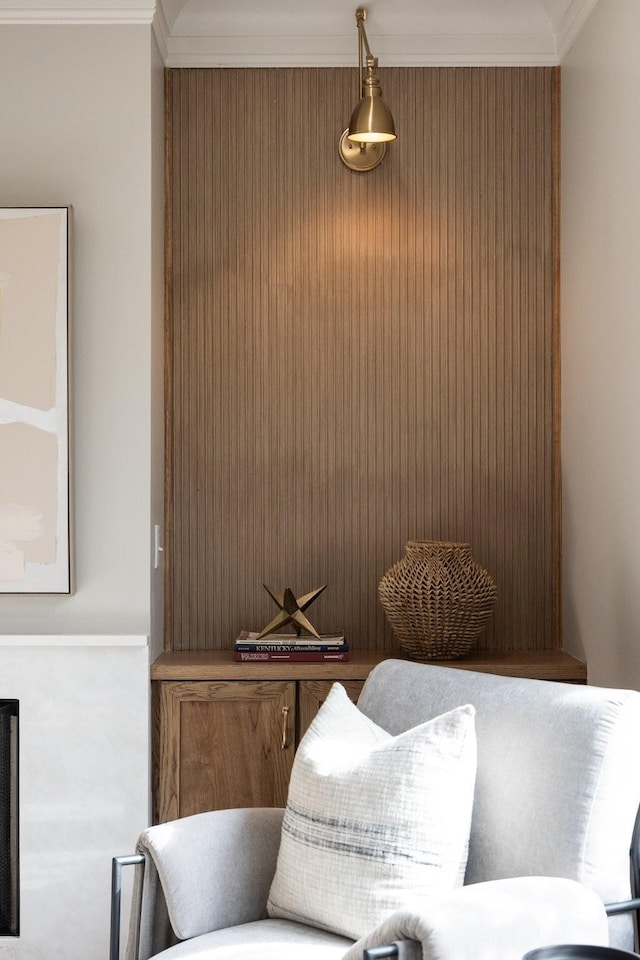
xmin=0 ymin=25 xmax=163 ymax=649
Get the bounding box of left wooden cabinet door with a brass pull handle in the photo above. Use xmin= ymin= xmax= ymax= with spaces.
xmin=154 ymin=681 xmax=295 ymax=823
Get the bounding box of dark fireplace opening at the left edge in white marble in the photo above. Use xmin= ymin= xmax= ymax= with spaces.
xmin=0 ymin=700 xmax=20 ymax=937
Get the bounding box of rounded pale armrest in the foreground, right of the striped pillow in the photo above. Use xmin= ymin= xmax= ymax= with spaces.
xmin=350 ymin=877 xmax=609 ymax=960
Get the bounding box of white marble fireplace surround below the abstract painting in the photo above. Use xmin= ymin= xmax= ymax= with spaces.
xmin=0 ymin=636 xmax=150 ymax=960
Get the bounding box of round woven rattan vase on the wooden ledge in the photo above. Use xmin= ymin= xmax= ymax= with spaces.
xmin=378 ymin=540 xmax=496 ymax=660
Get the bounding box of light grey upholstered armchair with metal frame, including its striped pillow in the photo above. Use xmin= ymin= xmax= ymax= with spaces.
xmin=111 ymin=660 xmax=640 ymax=960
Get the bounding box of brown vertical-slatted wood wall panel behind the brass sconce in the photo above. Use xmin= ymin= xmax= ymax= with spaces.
xmin=167 ymin=68 xmax=559 ymax=650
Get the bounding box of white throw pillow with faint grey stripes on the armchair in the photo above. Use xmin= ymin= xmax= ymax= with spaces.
xmin=268 ymin=683 xmax=476 ymax=940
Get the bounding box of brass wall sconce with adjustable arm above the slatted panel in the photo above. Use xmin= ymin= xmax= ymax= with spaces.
xmin=339 ymin=7 xmax=396 ymax=171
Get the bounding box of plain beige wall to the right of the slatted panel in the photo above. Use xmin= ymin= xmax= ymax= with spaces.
xmin=561 ymin=0 xmax=640 ymax=688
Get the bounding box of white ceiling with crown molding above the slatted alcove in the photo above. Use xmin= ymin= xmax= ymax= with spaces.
xmin=0 ymin=0 xmax=598 ymax=67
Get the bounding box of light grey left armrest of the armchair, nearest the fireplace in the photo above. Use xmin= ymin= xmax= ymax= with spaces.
xmin=127 ymin=807 xmax=283 ymax=960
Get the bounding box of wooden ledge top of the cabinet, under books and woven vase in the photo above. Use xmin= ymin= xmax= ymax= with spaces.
xmin=151 ymin=650 xmax=587 ymax=683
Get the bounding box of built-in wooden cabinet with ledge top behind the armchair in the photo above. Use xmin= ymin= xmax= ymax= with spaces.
xmin=151 ymin=651 xmax=586 ymax=823
